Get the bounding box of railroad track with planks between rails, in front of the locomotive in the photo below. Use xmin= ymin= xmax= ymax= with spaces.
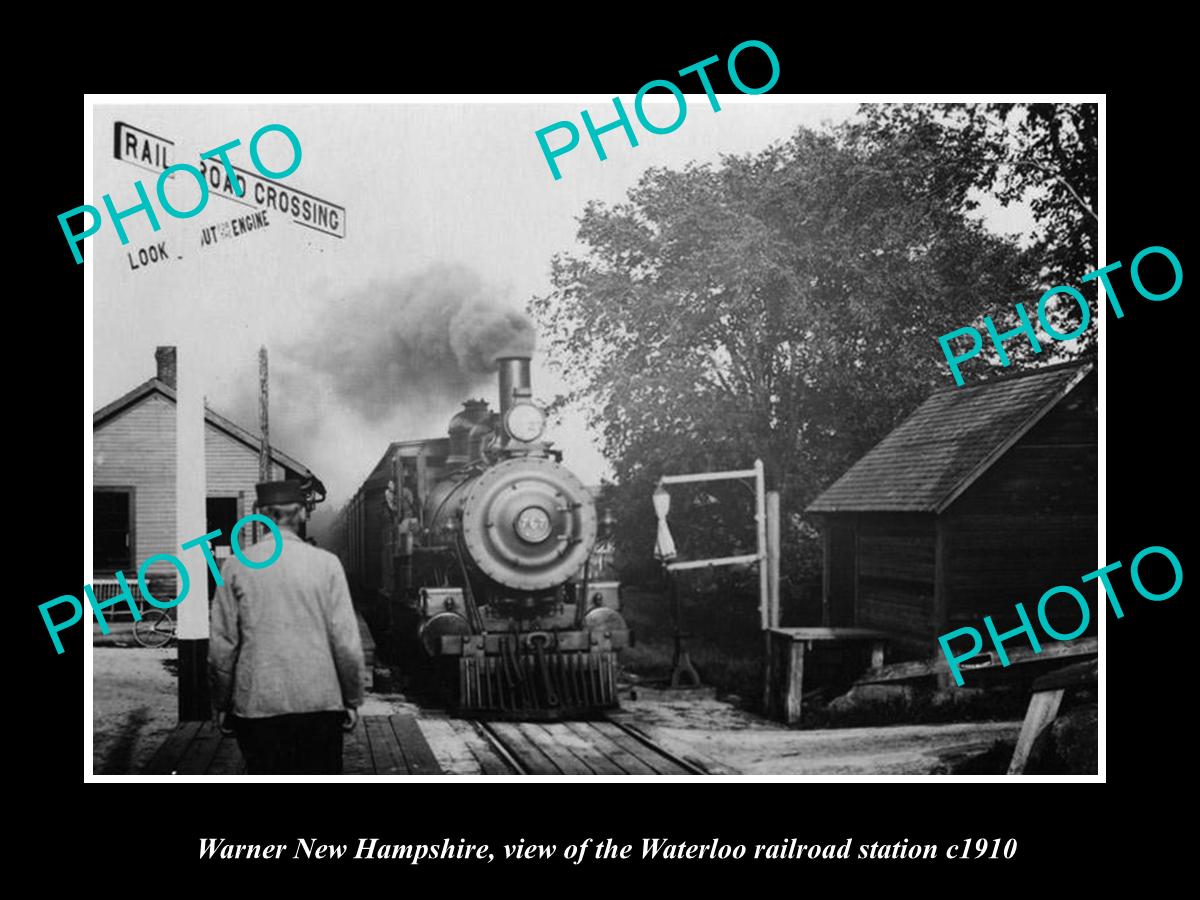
xmin=473 ymin=718 xmax=716 ymax=775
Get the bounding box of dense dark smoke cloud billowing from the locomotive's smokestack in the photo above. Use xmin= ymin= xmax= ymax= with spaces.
xmin=286 ymin=265 xmax=535 ymax=419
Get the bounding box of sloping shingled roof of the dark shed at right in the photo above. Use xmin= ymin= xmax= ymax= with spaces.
xmin=808 ymin=360 xmax=1094 ymax=512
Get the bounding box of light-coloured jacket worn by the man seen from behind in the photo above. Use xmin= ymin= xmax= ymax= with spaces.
xmin=209 ymin=529 xmax=364 ymax=719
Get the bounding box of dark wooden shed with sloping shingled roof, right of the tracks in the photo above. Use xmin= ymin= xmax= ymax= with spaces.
xmin=808 ymin=359 xmax=1098 ymax=654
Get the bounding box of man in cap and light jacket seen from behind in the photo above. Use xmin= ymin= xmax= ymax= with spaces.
xmin=209 ymin=481 xmax=365 ymax=775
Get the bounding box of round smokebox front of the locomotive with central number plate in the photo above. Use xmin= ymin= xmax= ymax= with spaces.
xmin=462 ymin=456 xmax=596 ymax=590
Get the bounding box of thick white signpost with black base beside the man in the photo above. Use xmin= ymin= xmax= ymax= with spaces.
xmin=175 ymin=343 xmax=209 ymax=719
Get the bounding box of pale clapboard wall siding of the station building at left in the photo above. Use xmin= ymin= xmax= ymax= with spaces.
xmin=92 ymin=394 xmax=286 ymax=576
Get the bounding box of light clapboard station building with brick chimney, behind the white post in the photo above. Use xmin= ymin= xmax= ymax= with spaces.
xmin=92 ymin=347 xmax=308 ymax=596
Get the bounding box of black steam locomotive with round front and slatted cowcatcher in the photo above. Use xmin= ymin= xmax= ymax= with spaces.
xmin=335 ymin=356 xmax=630 ymax=719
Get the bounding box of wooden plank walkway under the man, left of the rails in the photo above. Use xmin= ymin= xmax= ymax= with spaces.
xmin=144 ymin=715 xmax=446 ymax=775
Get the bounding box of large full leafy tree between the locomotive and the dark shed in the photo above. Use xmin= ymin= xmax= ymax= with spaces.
xmin=530 ymin=120 xmax=1036 ymax=600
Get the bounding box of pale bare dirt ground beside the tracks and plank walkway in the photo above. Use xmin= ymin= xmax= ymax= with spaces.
xmin=92 ymin=647 xmax=1020 ymax=775
